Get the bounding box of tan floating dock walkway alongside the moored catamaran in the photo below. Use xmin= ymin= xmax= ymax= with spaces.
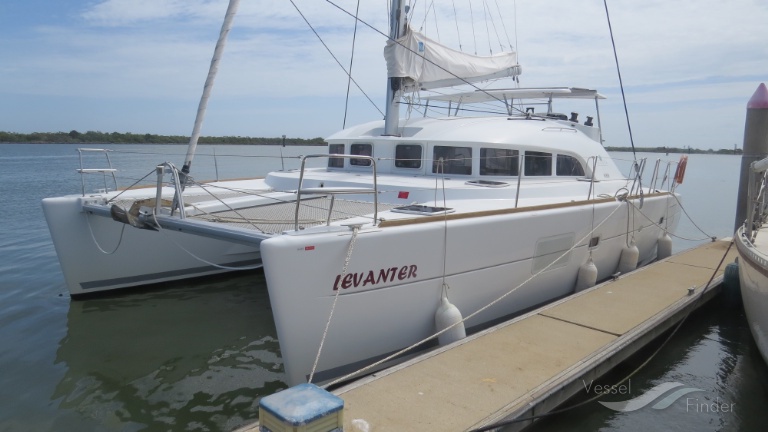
xmin=237 ymin=241 xmax=736 ymax=431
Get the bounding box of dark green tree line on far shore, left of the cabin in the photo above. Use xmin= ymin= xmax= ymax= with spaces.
xmin=0 ymin=130 xmax=325 ymax=145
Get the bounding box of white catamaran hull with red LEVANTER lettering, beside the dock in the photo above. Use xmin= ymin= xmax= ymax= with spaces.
xmin=261 ymin=194 xmax=679 ymax=385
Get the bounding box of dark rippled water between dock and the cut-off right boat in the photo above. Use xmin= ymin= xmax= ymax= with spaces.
xmin=530 ymin=296 xmax=768 ymax=432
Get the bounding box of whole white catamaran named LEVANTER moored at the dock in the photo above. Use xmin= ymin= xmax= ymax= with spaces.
xmin=43 ymin=0 xmax=684 ymax=384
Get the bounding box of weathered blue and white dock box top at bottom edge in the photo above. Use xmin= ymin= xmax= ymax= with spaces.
xmin=259 ymin=383 xmax=344 ymax=432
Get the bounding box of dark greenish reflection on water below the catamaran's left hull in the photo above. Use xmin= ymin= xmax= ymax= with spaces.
xmin=51 ymin=272 xmax=286 ymax=430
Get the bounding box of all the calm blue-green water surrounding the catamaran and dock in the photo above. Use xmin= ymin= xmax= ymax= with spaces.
xmin=0 ymin=145 xmax=768 ymax=432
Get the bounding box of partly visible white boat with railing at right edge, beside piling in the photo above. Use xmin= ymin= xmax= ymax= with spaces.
xmin=734 ymin=158 xmax=768 ymax=363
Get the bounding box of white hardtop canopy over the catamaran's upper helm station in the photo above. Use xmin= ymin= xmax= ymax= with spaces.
xmin=426 ymin=87 xmax=605 ymax=103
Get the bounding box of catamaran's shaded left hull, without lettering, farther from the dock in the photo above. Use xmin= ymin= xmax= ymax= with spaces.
xmin=42 ymin=195 xmax=261 ymax=296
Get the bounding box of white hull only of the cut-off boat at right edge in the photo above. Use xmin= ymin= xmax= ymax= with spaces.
xmin=735 ymin=228 xmax=768 ymax=363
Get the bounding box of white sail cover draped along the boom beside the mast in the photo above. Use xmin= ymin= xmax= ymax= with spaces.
xmin=384 ymin=29 xmax=520 ymax=90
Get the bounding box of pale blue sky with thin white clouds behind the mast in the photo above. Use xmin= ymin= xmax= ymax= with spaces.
xmin=0 ymin=0 xmax=768 ymax=149
